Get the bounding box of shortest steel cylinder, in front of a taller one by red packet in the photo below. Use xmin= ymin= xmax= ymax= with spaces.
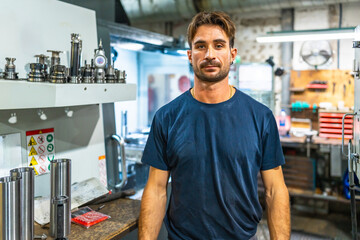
xmin=51 ymin=196 xmax=70 ymax=239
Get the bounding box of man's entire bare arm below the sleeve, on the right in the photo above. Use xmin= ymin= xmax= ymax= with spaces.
xmin=261 ymin=166 xmax=291 ymax=240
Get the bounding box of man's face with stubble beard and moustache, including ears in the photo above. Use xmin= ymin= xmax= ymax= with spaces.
xmin=188 ymin=25 xmax=237 ymax=82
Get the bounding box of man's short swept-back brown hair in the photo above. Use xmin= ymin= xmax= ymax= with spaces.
xmin=187 ymin=11 xmax=235 ymax=49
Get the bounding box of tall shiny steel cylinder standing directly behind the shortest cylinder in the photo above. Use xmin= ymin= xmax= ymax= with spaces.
xmin=50 ymin=159 xmax=71 ymax=237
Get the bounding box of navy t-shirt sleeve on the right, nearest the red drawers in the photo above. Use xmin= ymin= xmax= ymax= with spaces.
xmin=261 ymin=113 xmax=285 ymax=170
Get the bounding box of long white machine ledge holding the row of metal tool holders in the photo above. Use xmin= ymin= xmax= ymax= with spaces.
xmin=0 ymin=80 xmax=136 ymax=110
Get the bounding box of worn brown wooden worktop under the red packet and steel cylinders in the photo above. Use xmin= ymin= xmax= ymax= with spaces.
xmin=34 ymin=198 xmax=140 ymax=240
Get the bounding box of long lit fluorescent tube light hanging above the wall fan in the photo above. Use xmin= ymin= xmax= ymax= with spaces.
xmin=256 ymin=28 xmax=355 ymax=43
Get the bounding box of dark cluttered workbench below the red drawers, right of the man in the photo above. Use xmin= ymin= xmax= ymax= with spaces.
xmin=280 ymin=136 xmax=349 ymax=203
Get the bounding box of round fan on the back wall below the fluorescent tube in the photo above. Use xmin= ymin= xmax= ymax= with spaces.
xmin=300 ymin=40 xmax=332 ymax=67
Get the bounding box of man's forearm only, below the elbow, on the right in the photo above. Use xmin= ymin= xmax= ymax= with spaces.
xmin=266 ymin=186 xmax=291 ymax=240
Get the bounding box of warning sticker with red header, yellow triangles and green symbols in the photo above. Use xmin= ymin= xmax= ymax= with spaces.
xmin=26 ymin=128 xmax=55 ymax=175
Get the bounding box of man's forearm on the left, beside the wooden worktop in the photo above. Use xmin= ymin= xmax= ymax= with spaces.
xmin=139 ymin=187 xmax=167 ymax=240
